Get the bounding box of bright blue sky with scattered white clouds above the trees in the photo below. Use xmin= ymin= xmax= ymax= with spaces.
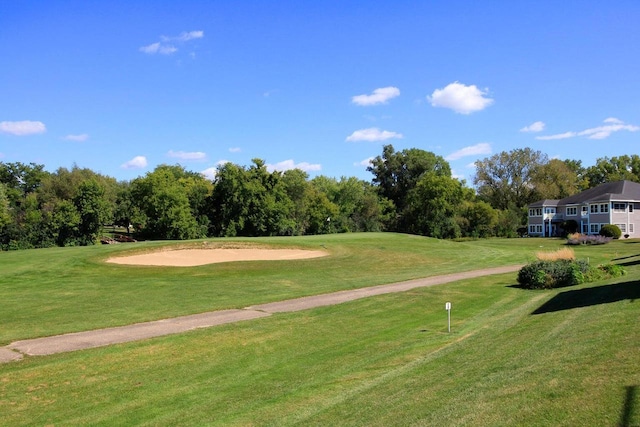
xmin=0 ymin=0 xmax=640 ymax=186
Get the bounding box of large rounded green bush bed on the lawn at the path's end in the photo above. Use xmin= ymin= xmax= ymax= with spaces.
xmin=518 ymin=259 xmax=626 ymax=289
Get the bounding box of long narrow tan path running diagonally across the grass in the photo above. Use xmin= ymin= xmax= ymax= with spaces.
xmin=0 ymin=265 xmax=521 ymax=363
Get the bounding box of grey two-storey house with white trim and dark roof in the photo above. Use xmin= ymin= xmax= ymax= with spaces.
xmin=528 ymin=181 xmax=640 ymax=237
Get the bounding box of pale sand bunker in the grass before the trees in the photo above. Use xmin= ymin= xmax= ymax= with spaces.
xmin=107 ymin=249 xmax=328 ymax=267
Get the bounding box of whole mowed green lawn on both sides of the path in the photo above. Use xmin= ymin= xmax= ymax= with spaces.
xmin=0 ymin=234 xmax=640 ymax=426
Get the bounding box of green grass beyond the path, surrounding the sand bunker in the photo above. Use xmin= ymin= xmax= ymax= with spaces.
xmin=0 ymin=233 xmax=576 ymax=344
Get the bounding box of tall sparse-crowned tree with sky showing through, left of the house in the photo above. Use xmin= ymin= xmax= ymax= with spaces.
xmin=473 ymin=148 xmax=548 ymax=210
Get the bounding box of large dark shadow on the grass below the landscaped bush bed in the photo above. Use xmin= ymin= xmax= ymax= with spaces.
xmin=531 ymin=280 xmax=640 ymax=314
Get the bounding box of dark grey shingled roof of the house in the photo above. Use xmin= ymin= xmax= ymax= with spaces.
xmin=529 ymin=180 xmax=640 ymax=207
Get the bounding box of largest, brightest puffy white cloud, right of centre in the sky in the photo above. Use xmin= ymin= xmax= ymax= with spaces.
xmin=427 ymin=82 xmax=493 ymax=114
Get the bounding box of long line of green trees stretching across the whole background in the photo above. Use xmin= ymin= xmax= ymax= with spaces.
xmin=0 ymin=145 xmax=640 ymax=250
